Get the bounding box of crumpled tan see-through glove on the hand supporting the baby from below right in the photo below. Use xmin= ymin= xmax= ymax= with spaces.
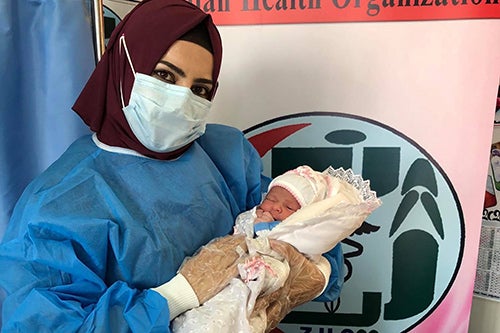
xmin=250 ymin=240 xmax=326 ymax=332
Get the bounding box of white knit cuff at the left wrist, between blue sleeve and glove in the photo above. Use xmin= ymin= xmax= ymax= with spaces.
xmin=151 ymin=274 xmax=200 ymax=320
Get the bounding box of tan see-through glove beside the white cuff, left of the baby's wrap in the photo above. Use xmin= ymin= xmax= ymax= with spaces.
xmin=179 ymin=235 xmax=247 ymax=304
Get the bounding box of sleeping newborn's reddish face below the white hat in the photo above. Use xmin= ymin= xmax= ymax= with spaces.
xmin=259 ymin=186 xmax=300 ymax=221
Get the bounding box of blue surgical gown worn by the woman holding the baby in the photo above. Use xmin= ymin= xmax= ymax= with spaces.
xmin=0 ymin=125 xmax=343 ymax=332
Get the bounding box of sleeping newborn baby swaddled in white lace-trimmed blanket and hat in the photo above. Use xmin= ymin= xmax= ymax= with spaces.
xmin=172 ymin=166 xmax=380 ymax=333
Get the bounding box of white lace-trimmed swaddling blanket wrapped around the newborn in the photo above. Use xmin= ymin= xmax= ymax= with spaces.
xmin=172 ymin=167 xmax=381 ymax=333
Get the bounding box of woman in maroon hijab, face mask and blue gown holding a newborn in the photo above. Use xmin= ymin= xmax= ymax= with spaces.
xmin=0 ymin=0 xmax=342 ymax=332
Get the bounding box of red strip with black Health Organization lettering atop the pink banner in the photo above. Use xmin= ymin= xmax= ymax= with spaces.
xmin=190 ymin=0 xmax=500 ymax=25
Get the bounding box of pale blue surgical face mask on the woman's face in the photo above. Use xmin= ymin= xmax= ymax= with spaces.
xmin=120 ymin=36 xmax=212 ymax=153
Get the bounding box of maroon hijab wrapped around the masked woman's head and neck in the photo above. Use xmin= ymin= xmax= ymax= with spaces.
xmin=73 ymin=0 xmax=222 ymax=160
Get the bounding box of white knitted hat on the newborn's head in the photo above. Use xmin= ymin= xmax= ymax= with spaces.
xmin=268 ymin=165 xmax=329 ymax=207
